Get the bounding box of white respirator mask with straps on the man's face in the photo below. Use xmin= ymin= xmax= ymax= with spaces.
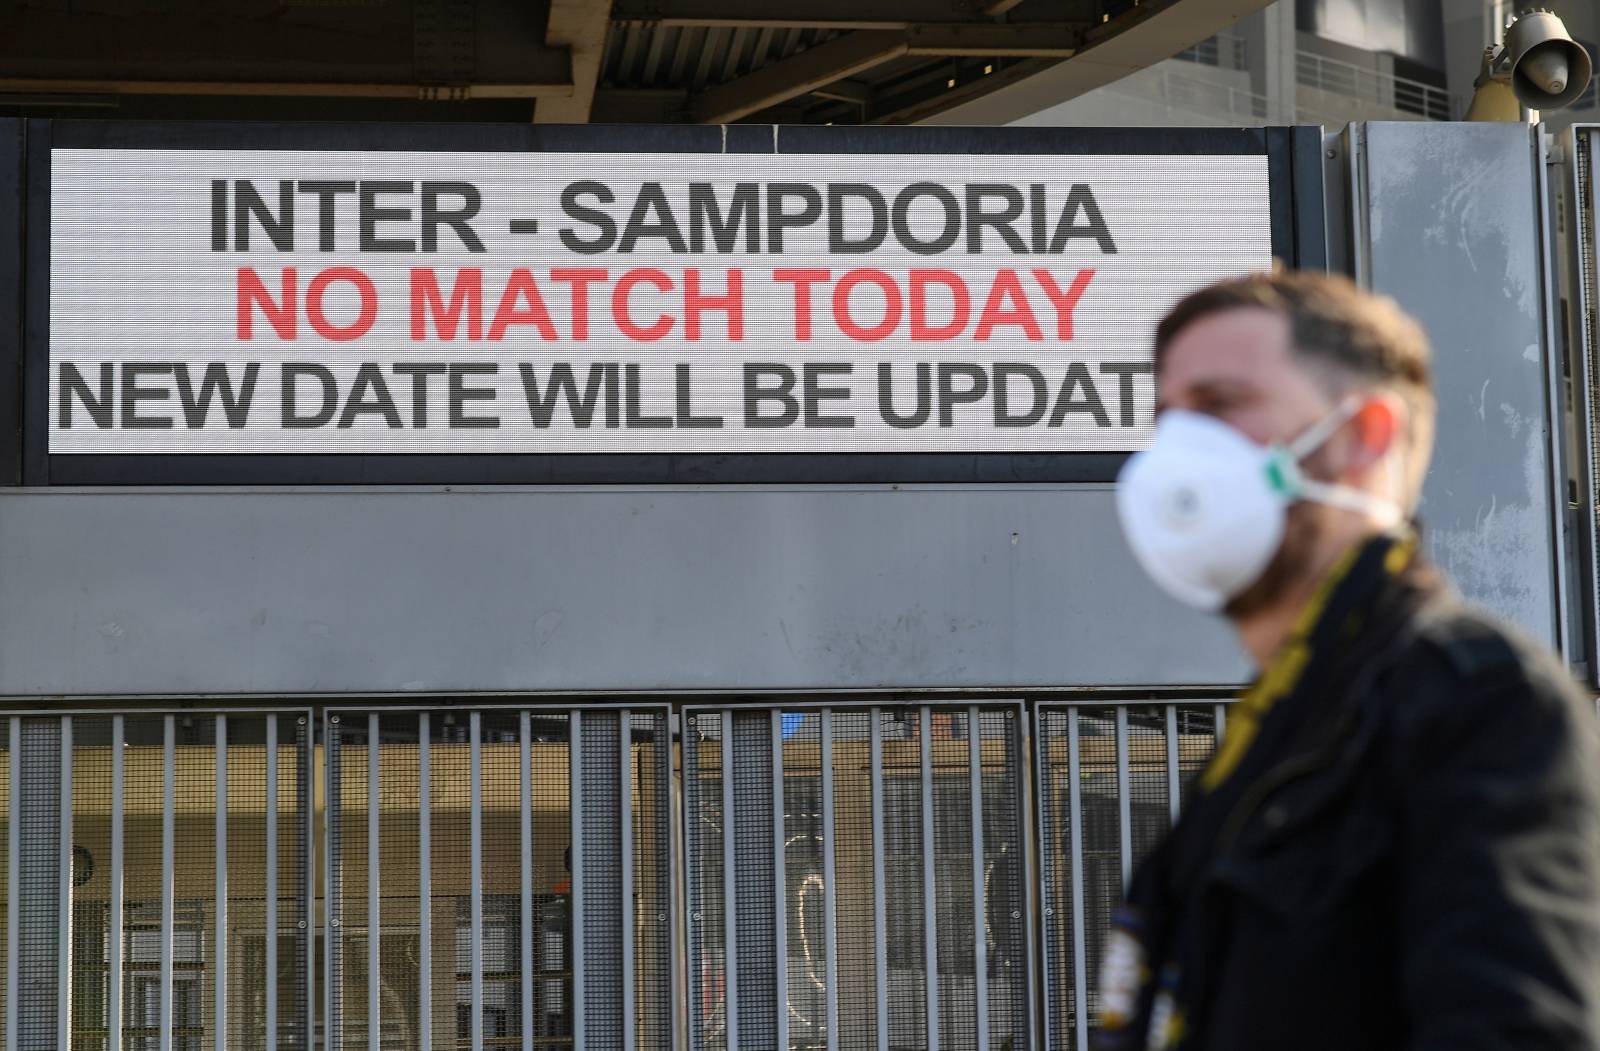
xmin=1117 ymin=397 xmax=1403 ymax=611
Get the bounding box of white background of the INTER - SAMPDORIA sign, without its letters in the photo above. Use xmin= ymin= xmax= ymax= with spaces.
xmin=50 ymin=149 xmax=1270 ymax=454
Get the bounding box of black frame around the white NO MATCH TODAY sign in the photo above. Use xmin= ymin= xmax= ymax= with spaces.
xmin=12 ymin=120 xmax=1328 ymax=486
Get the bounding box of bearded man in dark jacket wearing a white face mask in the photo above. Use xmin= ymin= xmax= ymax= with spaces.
xmin=1096 ymin=274 xmax=1600 ymax=1051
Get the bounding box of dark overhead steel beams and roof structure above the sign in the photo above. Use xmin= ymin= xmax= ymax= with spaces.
xmin=0 ymin=0 xmax=1262 ymax=125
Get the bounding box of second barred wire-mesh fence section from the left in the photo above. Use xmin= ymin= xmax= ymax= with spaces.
xmin=326 ymin=707 xmax=672 ymax=1051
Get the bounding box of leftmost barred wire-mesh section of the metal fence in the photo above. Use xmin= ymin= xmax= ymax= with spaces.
xmin=0 ymin=710 xmax=312 ymax=1051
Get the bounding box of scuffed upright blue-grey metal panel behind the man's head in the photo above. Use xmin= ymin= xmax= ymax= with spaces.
xmin=1355 ymin=123 xmax=1557 ymax=645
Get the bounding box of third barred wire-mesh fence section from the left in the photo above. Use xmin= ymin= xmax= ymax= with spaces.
xmin=683 ymin=704 xmax=1030 ymax=1051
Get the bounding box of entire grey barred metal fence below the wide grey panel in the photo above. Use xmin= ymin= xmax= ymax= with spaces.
xmin=0 ymin=702 xmax=1224 ymax=1051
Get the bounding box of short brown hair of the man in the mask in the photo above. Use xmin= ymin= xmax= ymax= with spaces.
xmin=1155 ymin=270 xmax=1435 ymax=510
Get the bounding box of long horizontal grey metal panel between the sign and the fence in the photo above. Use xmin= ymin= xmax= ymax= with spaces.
xmin=0 ymin=486 xmax=1241 ymax=696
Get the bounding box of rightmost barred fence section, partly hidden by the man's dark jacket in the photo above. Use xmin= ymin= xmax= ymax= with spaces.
xmin=1034 ymin=704 xmax=1222 ymax=1051
